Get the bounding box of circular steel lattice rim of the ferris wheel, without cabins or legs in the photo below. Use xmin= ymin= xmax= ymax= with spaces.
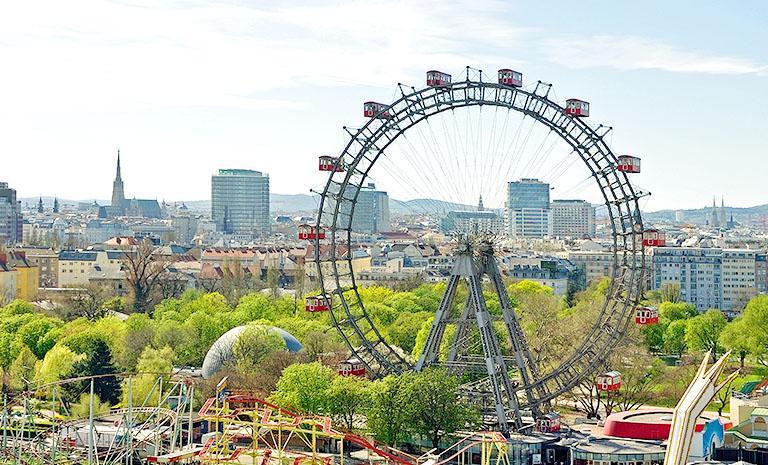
xmin=314 ymin=74 xmax=645 ymax=406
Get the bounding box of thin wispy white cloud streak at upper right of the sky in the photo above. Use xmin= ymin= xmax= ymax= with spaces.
xmin=544 ymin=35 xmax=768 ymax=74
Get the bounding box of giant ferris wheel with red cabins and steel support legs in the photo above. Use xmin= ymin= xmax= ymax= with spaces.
xmin=299 ymin=64 xmax=664 ymax=432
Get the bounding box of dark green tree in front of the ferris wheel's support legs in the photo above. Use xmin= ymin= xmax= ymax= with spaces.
xmin=408 ymin=369 xmax=479 ymax=448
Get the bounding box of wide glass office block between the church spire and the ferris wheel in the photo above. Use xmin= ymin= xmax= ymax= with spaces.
xmin=211 ymin=169 xmax=271 ymax=236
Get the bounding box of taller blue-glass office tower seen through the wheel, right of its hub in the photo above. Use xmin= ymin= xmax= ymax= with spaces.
xmin=507 ymin=179 xmax=552 ymax=238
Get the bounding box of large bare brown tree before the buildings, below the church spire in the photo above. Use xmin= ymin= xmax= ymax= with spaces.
xmin=123 ymin=239 xmax=171 ymax=313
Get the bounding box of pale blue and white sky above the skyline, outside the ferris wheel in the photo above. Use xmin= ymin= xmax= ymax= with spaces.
xmin=0 ymin=0 xmax=768 ymax=210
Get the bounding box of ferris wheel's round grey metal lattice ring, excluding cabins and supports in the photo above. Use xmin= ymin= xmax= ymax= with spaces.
xmin=314 ymin=73 xmax=646 ymax=428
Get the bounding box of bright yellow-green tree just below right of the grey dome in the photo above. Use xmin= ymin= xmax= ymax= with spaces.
xmin=270 ymin=362 xmax=334 ymax=415
